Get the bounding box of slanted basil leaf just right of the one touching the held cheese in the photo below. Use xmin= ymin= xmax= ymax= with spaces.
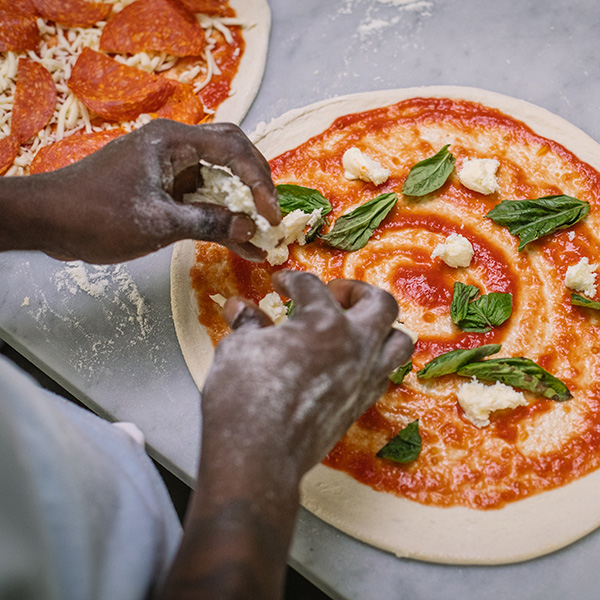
xmin=321 ymin=192 xmax=398 ymax=252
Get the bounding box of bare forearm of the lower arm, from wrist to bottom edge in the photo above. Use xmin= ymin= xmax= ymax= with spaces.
xmin=159 ymin=432 xmax=298 ymax=600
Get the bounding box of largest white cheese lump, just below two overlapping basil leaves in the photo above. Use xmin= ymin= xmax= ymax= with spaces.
xmin=456 ymin=378 xmax=527 ymax=427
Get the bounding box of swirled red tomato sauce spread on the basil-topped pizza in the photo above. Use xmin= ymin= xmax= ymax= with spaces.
xmin=192 ymin=98 xmax=600 ymax=508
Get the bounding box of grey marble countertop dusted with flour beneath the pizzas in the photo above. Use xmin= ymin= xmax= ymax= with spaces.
xmin=0 ymin=0 xmax=600 ymax=600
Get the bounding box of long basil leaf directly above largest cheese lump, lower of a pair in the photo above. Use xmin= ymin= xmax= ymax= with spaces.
xmin=457 ymin=358 xmax=572 ymax=402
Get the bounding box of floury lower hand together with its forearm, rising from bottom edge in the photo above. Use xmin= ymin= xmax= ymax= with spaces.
xmin=166 ymin=271 xmax=413 ymax=598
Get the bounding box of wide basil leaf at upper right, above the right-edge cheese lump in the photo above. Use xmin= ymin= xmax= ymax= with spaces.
xmin=486 ymin=195 xmax=590 ymax=252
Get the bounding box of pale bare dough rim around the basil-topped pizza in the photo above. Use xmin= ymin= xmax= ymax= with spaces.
xmin=172 ymin=86 xmax=600 ymax=564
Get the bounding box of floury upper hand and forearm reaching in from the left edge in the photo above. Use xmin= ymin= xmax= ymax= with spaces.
xmin=0 ymin=120 xmax=281 ymax=263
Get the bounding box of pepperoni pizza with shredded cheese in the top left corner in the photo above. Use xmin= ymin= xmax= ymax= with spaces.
xmin=0 ymin=0 xmax=270 ymax=175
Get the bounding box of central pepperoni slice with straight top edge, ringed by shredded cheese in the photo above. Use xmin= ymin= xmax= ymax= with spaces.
xmin=69 ymin=48 xmax=173 ymax=121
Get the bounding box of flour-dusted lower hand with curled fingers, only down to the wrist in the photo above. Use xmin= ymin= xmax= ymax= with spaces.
xmin=202 ymin=271 xmax=413 ymax=477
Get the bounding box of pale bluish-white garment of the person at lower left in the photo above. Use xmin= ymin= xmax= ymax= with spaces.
xmin=0 ymin=359 xmax=181 ymax=600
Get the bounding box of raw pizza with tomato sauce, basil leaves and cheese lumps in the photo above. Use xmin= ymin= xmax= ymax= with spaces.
xmin=172 ymin=87 xmax=600 ymax=564
